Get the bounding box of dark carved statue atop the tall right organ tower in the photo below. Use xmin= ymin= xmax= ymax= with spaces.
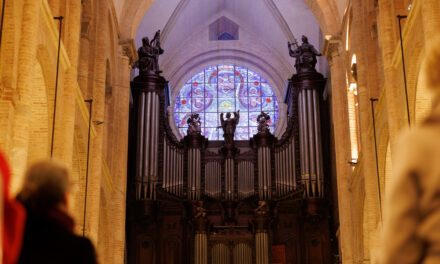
xmin=287 ymin=35 xmax=322 ymax=73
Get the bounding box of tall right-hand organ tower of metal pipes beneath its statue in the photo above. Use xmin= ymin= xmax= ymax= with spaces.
xmin=292 ymin=71 xmax=325 ymax=198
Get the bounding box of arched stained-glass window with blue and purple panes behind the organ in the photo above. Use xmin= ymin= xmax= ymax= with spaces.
xmin=174 ymin=64 xmax=278 ymax=140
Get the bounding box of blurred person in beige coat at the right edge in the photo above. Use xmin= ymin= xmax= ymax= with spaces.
xmin=382 ymin=37 xmax=440 ymax=264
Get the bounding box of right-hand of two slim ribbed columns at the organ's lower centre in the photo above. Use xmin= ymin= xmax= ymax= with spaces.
xmin=254 ymin=211 xmax=270 ymax=264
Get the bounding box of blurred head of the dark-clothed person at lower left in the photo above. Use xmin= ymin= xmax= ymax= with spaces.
xmin=18 ymin=160 xmax=70 ymax=211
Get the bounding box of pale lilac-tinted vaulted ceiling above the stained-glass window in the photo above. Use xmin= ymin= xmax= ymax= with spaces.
xmin=135 ymin=0 xmax=330 ymax=95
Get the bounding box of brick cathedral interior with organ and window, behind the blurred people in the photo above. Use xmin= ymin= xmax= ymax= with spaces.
xmin=0 ymin=0 xmax=440 ymax=264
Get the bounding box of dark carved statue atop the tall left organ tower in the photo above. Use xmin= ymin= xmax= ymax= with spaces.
xmin=137 ymin=30 xmax=163 ymax=74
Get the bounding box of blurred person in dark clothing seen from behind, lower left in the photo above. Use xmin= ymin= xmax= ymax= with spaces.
xmin=17 ymin=160 xmax=96 ymax=264
